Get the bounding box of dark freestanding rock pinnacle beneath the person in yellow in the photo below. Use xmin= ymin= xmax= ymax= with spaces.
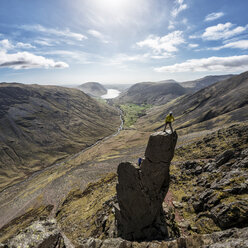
xmin=115 ymin=132 xmax=177 ymax=240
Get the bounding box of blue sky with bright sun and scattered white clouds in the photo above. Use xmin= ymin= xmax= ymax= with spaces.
xmin=0 ymin=0 xmax=248 ymax=84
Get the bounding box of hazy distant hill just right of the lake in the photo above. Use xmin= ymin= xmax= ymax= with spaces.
xmin=115 ymin=80 xmax=187 ymax=105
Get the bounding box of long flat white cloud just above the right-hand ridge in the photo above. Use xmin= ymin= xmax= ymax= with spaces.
xmin=155 ymin=55 xmax=248 ymax=73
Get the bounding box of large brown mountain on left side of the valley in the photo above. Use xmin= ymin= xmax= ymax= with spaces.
xmin=0 ymin=83 xmax=120 ymax=189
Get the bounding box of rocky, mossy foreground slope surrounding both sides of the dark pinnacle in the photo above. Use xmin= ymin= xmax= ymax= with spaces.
xmin=0 ymin=125 xmax=248 ymax=248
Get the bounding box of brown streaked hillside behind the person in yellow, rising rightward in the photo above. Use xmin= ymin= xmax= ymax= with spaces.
xmin=139 ymin=72 xmax=248 ymax=129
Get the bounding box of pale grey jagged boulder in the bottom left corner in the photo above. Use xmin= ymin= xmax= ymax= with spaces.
xmin=4 ymin=219 xmax=66 ymax=248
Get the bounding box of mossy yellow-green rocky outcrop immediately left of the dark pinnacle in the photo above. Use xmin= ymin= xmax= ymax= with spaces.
xmin=56 ymin=173 xmax=117 ymax=246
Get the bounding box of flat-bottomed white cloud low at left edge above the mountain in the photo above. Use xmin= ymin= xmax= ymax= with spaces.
xmin=0 ymin=51 xmax=69 ymax=70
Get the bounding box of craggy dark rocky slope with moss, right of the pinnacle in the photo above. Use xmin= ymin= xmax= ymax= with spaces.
xmin=171 ymin=125 xmax=248 ymax=234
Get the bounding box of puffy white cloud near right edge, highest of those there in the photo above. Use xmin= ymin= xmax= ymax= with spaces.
xmin=202 ymin=22 xmax=247 ymax=40
